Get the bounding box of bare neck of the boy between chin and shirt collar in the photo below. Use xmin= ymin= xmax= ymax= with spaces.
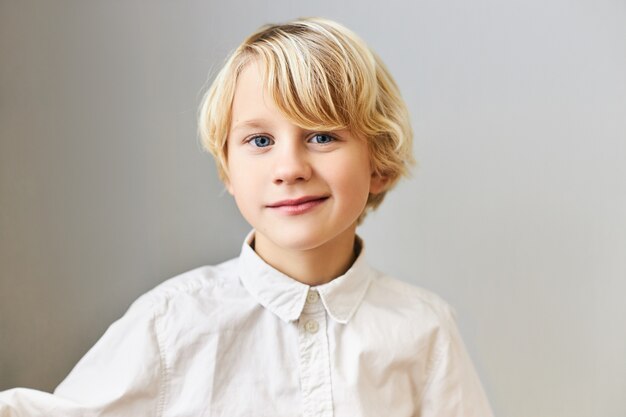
xmin=254 ymin=225 xmax=356 ymax=286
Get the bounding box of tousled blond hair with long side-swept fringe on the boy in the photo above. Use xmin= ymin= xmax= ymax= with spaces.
xmin=198 ymin=18 xmax=415 ymax=218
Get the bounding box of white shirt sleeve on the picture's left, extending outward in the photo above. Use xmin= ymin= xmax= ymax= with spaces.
xmin=0 ymin=294 xmax=164 ymax=417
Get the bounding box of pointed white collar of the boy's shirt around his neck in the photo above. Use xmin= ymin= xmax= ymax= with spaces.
xmin=239 ymin=230 xmax=373 ymax=324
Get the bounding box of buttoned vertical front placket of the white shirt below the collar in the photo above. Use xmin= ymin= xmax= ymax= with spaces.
xmin=298 ymin=290 xmax=333 ymax=417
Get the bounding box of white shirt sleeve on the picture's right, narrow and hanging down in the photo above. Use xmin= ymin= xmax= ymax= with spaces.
xmin=419 ymin=307 xmax=493 ymax=417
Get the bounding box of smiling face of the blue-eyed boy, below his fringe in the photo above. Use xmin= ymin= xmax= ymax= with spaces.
xmin=222 ymin=62 xmax=384 ymax=251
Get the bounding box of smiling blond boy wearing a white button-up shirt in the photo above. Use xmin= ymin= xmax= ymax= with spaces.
xmin=0 ymin=19 xmax=491 ymax=417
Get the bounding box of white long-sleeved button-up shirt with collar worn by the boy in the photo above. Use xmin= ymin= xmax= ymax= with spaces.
xmin=0 ymin=233 xmax=492 ymax=417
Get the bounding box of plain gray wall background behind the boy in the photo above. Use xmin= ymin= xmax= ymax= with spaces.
xmin=0 ymin=0 xmax=626 ymax=417
